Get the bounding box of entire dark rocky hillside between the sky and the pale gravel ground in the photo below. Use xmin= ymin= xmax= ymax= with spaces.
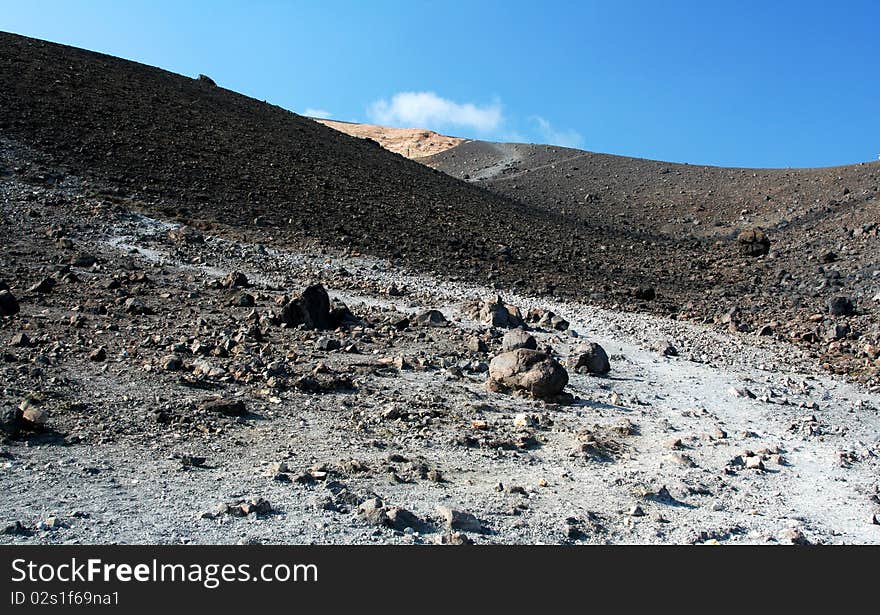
xmin=0 ymin=33 xmax=880 ymax=386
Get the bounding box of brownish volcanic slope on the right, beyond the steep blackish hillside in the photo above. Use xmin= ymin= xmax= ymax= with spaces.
xmin=424 ymin=141 xmax=880 ymax=380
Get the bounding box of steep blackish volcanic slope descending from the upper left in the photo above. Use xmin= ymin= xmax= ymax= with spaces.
xmin=0 ymin=34 xmax=600 ymax=300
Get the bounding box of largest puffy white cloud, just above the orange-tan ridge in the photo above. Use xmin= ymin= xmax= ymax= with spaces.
xmin=367 ymin=92 xmax=504 ymax=133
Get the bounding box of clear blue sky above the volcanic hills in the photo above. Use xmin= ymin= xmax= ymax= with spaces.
xmin=0 ymin=0 xmax=880 ymax=167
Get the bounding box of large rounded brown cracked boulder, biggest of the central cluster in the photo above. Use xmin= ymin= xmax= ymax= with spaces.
xmin=487 ymin=348 xmax=568 ymax=397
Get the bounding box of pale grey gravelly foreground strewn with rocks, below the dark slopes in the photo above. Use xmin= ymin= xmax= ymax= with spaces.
xmin=0 ymin=139 xmax=880 ymax=544
